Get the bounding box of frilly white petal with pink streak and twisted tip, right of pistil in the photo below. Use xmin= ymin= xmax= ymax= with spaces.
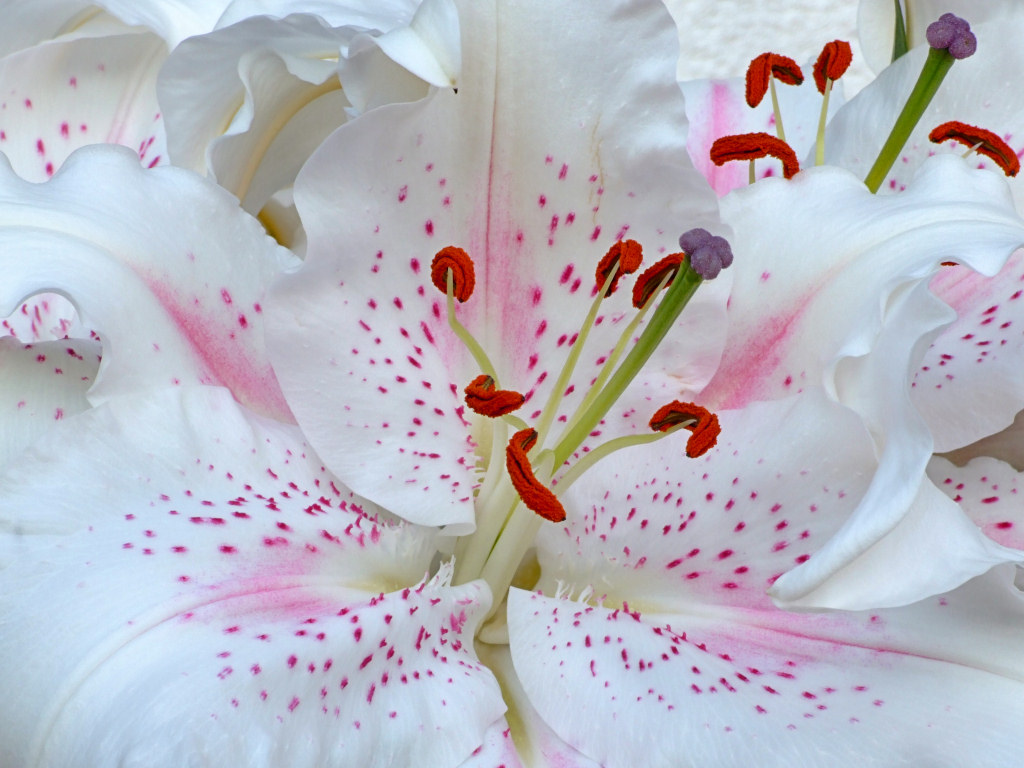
xmin=703 ymin=157 xmax=1024 ymax=608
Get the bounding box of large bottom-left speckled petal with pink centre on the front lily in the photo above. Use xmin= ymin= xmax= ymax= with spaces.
xmin=0 ymin=387 xmax=505 ymax=768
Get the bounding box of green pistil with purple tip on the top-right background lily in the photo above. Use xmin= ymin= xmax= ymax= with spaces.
xmin=864 ymin=13 xmax=978 ymax=193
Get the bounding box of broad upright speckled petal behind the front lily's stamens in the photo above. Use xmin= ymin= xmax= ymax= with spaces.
xmin=268 ymin=1 xmax=727 ymax=525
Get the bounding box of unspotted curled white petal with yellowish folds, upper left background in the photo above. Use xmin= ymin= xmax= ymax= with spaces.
xmin=159 ymin=15 xmax=356 ymax=214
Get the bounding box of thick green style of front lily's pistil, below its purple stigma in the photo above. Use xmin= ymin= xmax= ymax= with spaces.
xmin=554 ymin=263 xmax=703 ymax=467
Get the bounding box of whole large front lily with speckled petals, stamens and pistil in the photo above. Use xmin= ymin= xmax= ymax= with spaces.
xmin=6 ymin=0 xmax=1024 ymax=768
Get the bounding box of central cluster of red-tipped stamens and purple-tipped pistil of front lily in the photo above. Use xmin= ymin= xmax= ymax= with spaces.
xmin=431 ymin=229 xmax=732 ymax=612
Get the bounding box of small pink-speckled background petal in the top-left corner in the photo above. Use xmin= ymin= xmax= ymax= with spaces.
xmin=0 ymin=29 xmax=167 ymax=181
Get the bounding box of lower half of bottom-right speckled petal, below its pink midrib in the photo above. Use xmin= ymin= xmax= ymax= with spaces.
xmin=509 ymin=570 xmax=1024 ymax=768
